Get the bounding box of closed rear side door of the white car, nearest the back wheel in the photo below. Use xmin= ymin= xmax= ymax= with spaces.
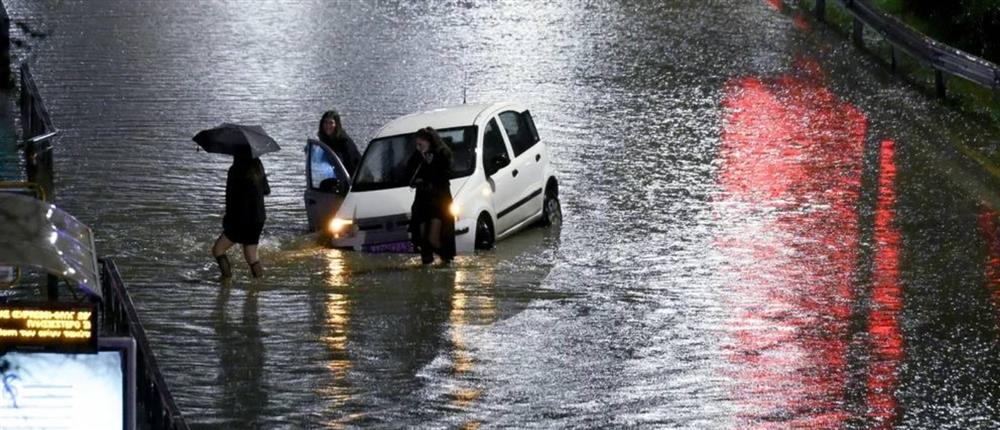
xmin=498 ymin=110 xmax=547 ymax=225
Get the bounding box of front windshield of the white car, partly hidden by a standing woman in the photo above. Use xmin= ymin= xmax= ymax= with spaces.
xmin=352 ymin=127 xmax=476 ymax=191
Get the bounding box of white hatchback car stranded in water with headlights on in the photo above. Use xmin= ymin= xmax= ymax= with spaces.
xmin=305 ymin=103 xmax=562 ymax=253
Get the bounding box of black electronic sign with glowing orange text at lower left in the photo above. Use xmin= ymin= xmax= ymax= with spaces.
xmin=0 ymin=303 xmax=97 ymax=352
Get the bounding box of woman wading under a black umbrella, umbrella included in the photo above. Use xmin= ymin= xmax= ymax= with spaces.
xmin=194 ymin=124 xmax=280 ymax=279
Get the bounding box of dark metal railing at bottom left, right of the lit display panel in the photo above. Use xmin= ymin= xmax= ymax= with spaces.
xmin=100 ymin=258 xmax=190 ymax=430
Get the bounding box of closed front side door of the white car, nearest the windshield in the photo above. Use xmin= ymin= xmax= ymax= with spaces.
xmin=482 ymin=118 xmax=517 ymax=235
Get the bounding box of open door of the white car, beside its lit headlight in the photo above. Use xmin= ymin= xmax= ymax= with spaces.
xmin=304 ymin=139 xmax=351 ymax=231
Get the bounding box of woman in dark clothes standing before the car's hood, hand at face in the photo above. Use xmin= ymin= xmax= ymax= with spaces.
xmin=409 ymin=127 xmax=455 ymax=264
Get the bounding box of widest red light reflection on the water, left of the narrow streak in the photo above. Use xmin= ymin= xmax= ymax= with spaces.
xmin=717 ymin=60 xmax=867 ymax=428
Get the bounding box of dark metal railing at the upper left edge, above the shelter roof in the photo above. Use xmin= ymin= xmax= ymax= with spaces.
xmin=18 ymin=63 xmax=57 ymax=201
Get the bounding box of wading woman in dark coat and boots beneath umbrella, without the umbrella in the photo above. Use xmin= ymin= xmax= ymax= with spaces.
xmin=212 ymin=150 xmax=271 ymax=278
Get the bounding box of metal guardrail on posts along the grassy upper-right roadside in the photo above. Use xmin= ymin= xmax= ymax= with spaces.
xmin=815 ymin=0 xmax=1000 ymax=97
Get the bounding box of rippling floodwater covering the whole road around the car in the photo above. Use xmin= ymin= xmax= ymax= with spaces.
xmin=6 ymin=0 xmax=1000 ymax=428
